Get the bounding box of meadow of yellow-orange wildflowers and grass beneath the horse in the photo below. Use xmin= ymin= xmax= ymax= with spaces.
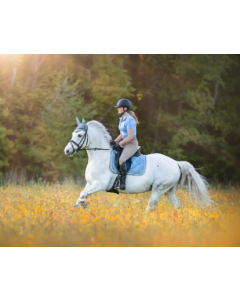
xmin=0 ymin=183 xmax=240 ymax=247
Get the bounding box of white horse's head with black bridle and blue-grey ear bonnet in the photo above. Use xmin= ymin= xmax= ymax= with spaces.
xmin=64 ymin=118 xmax=88 ymax=157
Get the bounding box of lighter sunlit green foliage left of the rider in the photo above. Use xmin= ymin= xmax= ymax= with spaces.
xmin=0 ymin=55 xmax=133 ymax=180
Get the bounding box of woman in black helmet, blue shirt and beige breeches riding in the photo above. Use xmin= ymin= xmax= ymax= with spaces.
xmin=111 ymin=99 xmax=139 ymax=190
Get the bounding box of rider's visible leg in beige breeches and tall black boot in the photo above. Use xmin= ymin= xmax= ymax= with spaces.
xmin=115 ymin=138 xmax=138 ymax=190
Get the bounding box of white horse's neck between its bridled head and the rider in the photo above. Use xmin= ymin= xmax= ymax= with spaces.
xmin=87 ymin=130 xmax=111 ymax=162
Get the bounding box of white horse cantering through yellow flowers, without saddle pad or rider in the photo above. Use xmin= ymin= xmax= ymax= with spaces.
xmin=64 ymin=119 xmax=213 ymax=211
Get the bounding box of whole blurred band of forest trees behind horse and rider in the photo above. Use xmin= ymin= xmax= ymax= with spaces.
xmin=0 ymin=54 xmax=240 ymax=182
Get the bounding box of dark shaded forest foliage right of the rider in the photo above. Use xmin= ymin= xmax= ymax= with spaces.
xmin=135 ymin=54 xmax=240 ymax=180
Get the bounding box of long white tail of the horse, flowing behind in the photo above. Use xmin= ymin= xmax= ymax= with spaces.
xmin=177 ymin=161 xmax=215 ymax=207
